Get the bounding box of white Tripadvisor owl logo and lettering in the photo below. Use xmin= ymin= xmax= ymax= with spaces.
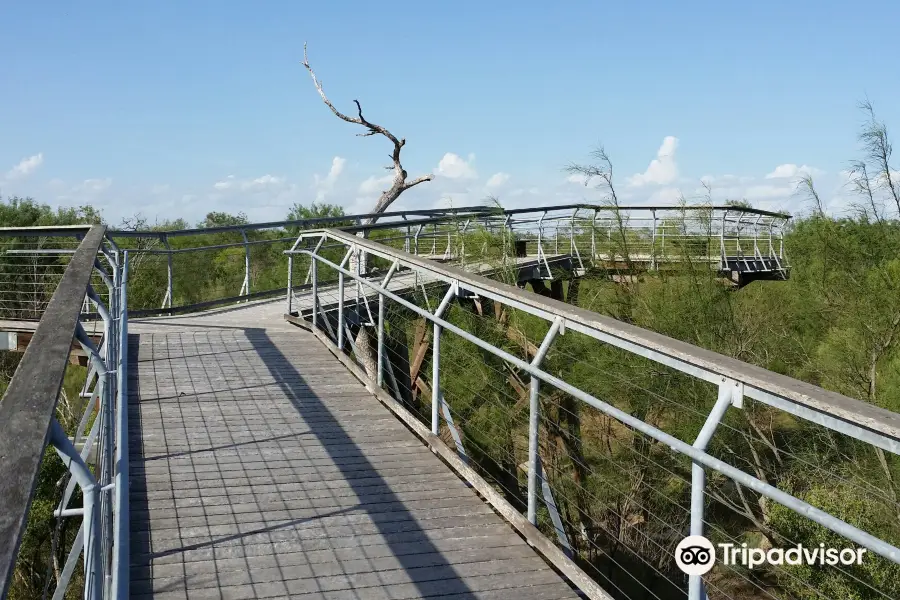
xmin=675 ymin=535 xmax=867 ymax=575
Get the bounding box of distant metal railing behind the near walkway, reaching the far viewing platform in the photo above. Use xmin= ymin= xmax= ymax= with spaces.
xmin=0 ymin=204 xmax=789 ymax=320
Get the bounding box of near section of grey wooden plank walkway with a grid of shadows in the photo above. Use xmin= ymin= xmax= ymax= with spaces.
xmin=129 ymin=328 xmax=577 ymax=600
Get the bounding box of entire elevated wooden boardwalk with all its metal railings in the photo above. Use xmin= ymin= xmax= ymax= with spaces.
xmin=0 ymin=205 xmax=900 ymax=600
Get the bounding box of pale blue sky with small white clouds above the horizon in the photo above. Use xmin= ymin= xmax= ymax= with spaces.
xmin=0 ymin=0 xmax=900 ymax=223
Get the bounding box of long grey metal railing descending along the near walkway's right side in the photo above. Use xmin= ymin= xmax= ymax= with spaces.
xmin=287 ymin=229 xmax=900 ymax=600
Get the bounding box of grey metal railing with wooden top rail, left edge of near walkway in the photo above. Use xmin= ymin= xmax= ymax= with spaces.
xmin=0 ymin=225 xmax=129 ymax=599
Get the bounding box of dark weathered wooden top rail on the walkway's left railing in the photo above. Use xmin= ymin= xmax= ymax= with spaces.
xmin=0 ymin=225 xmax=106 ymax=597
